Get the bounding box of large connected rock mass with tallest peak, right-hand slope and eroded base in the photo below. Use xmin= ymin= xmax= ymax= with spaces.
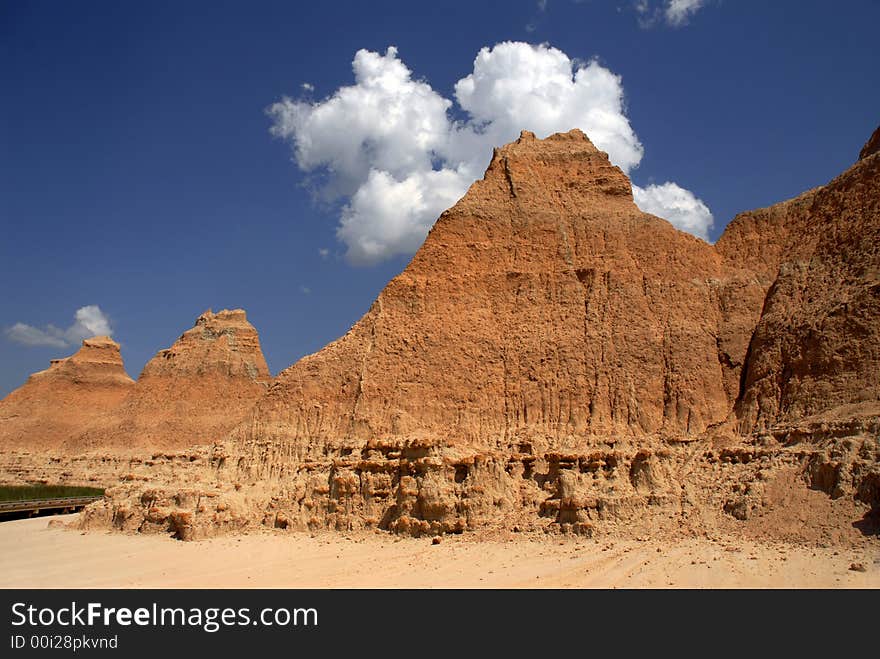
xmin=84 ymin=130 xmax=880 ymax=539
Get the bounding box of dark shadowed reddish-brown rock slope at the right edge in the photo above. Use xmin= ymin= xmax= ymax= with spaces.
xmin=737 ymin=132 xmax=880 ymax=433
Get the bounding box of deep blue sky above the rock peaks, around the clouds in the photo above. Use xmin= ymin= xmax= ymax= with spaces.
xmin=0 ymin=0 xmax=880 ymax=395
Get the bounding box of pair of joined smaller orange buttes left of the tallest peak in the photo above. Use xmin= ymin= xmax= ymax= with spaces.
xmin=0 ymin=309 xmax=271 ymax=454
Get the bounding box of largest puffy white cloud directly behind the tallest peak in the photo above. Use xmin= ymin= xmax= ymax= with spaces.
xmin=267 ymin=42 xmax=705 ymax=265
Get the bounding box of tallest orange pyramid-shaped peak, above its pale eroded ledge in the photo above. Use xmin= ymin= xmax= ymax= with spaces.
xmin=239 ymin=131 xmax=732 ymax=458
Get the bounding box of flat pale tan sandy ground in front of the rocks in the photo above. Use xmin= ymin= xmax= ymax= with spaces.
xmin=0 ymin=516 xmax=880 ymax=588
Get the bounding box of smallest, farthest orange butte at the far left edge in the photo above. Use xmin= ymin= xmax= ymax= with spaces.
xmin=0 ymin=336 xmax=135 ymax=450
